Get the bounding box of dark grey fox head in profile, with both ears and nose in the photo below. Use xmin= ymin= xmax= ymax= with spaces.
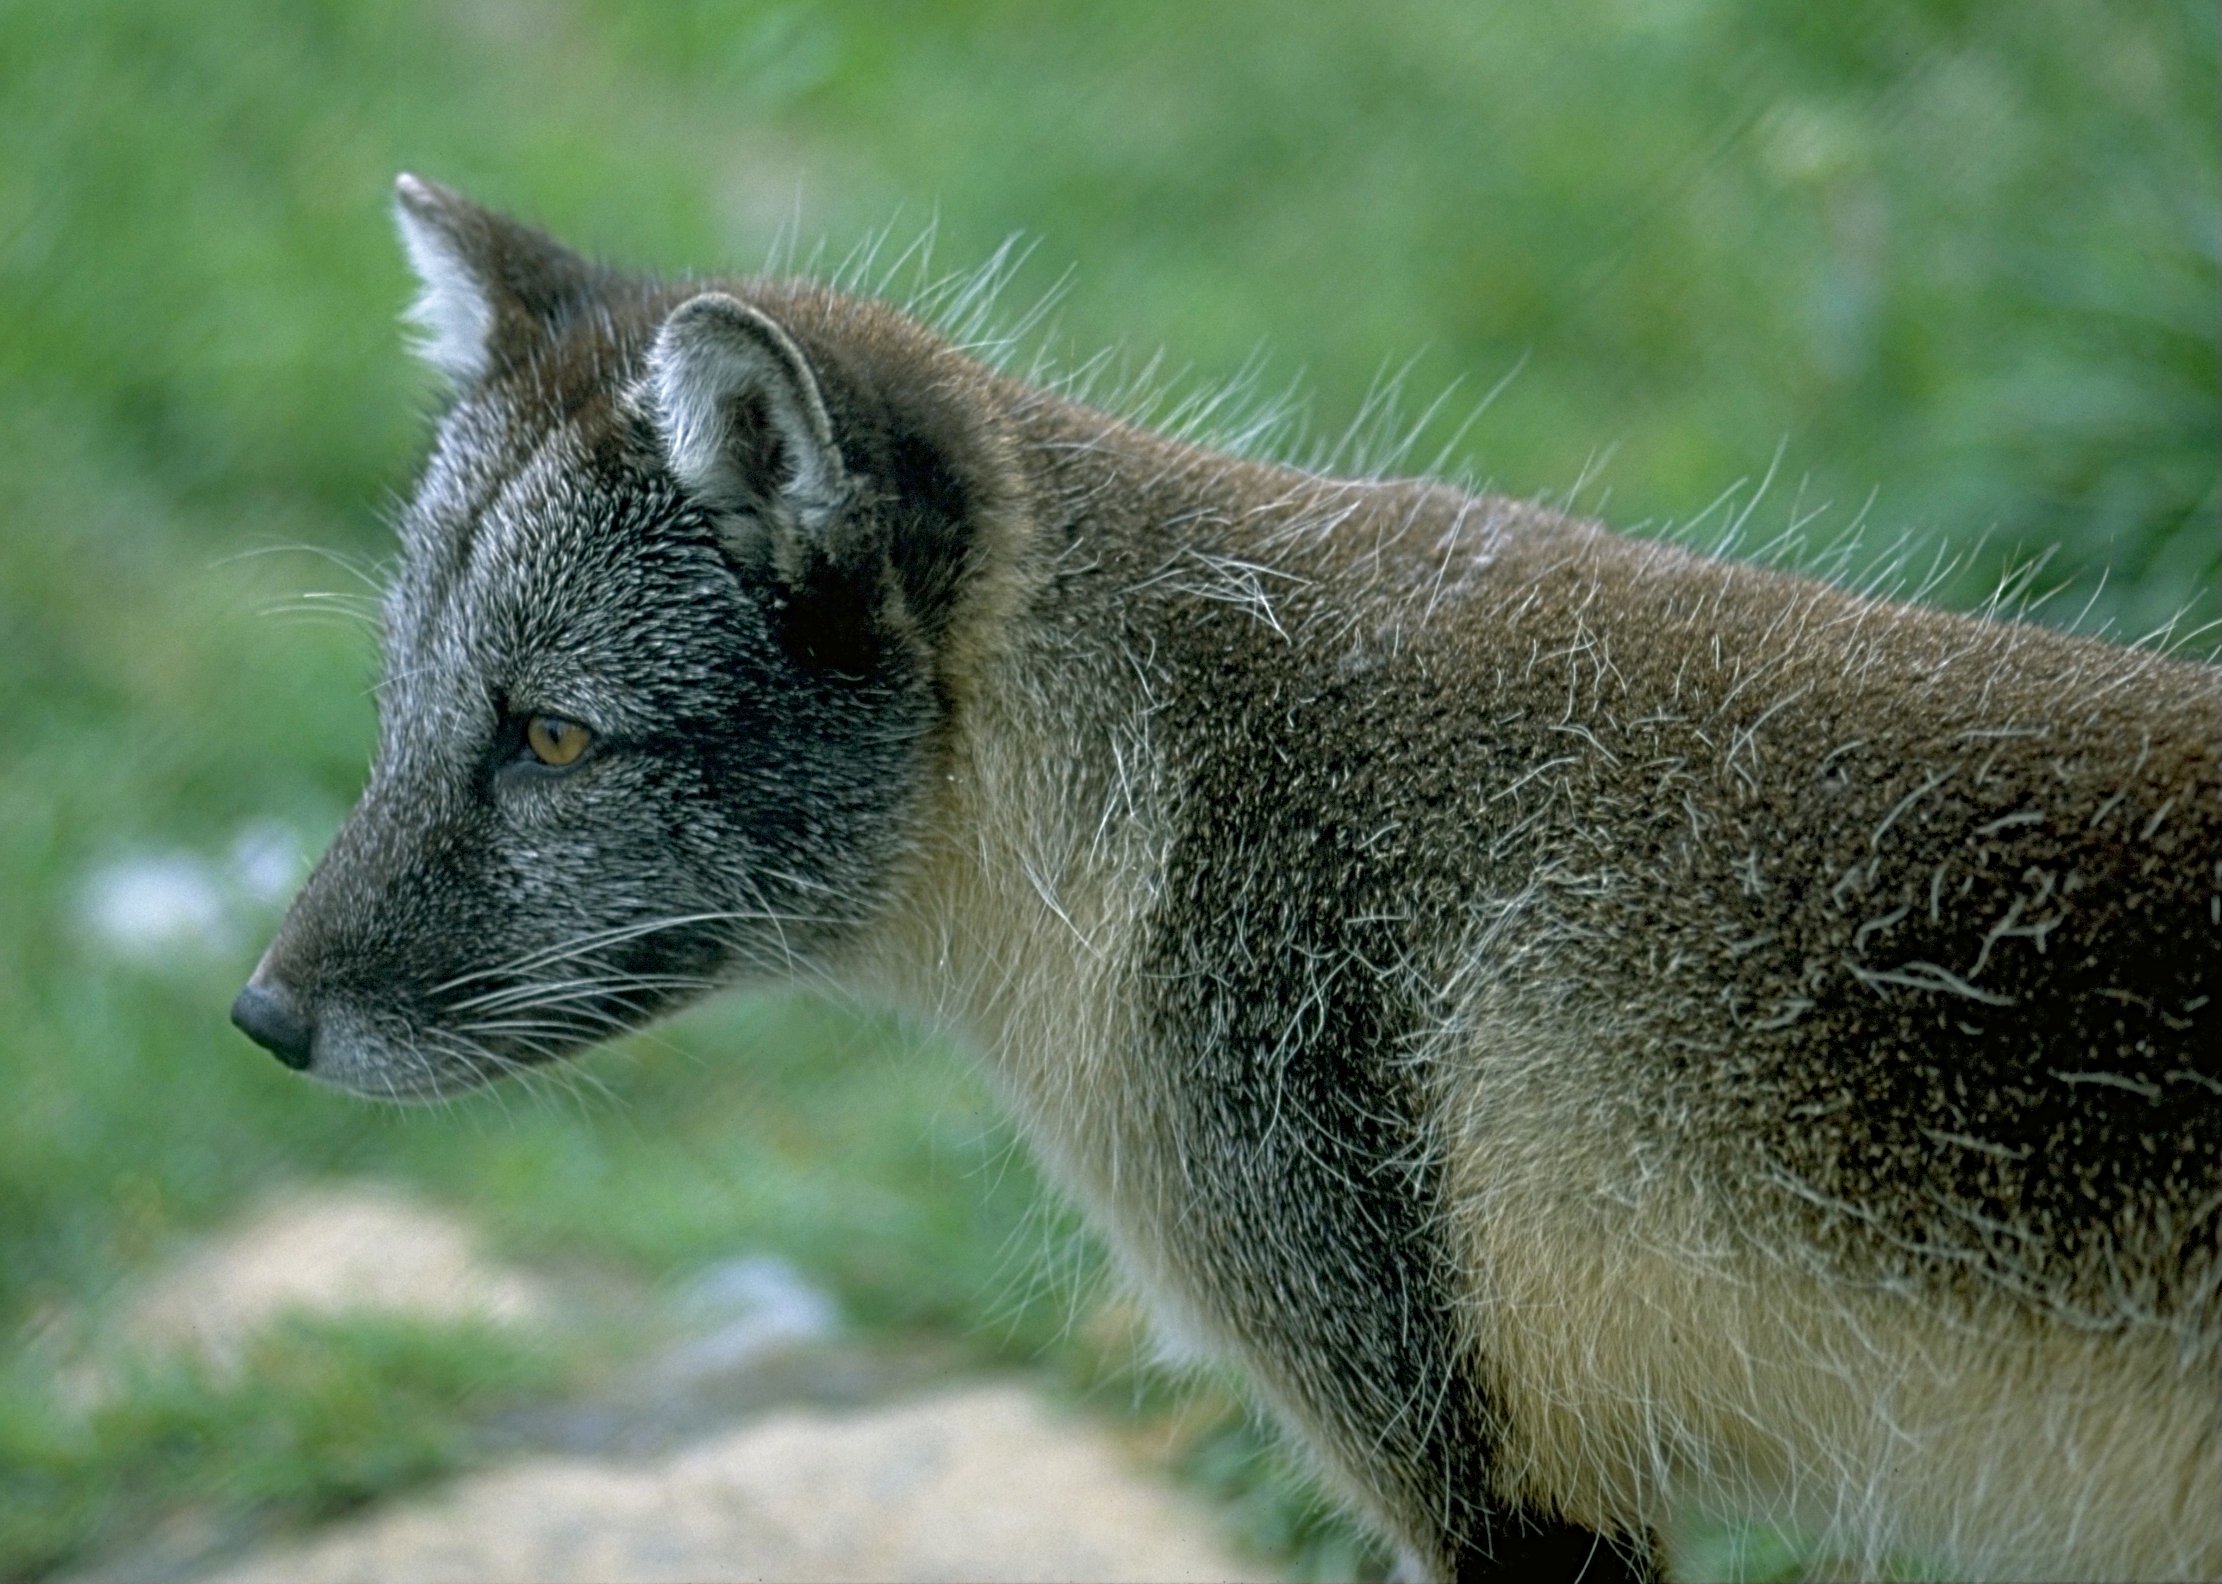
xmin=233 ymin=176 xmax=995 ymax=1095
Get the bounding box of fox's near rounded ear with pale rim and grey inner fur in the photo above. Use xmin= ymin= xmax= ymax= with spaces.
xmin=649 ymin=291 xmax=849 ymax=540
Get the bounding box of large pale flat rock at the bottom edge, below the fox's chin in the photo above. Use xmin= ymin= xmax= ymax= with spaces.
xmin=202 ymin=1384 xmax=1262 ymax=1584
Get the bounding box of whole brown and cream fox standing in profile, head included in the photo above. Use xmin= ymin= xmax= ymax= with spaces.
xmin=236 ymin=178 xmax=2222 ymax=1577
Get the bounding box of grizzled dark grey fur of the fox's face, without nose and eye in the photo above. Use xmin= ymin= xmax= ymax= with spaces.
xmin=258 ymin=178 xmax=938 ymax=1095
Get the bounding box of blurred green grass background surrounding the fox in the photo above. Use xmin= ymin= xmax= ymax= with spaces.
xmin=0 ymin=0 xmax=2222 ymax=1575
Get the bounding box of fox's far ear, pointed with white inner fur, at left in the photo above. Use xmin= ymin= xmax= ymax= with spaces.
xmin=393 ymin=173 xmax=604 ymax=387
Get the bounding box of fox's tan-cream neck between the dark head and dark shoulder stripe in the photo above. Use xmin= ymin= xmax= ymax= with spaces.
xmin=855 ymin=395 xmax=1238 ymax=1208
